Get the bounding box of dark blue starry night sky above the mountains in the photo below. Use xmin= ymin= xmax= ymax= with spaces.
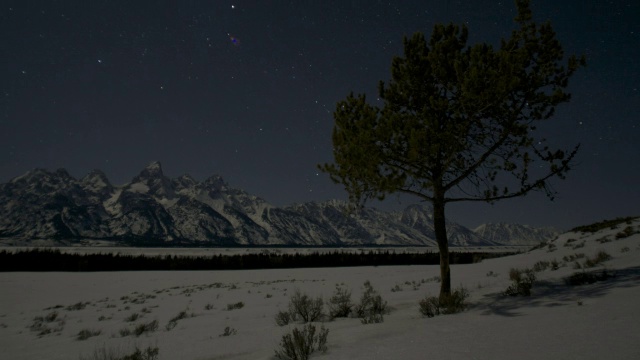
xmin=0 ymin=0 xmax=640 ymax=229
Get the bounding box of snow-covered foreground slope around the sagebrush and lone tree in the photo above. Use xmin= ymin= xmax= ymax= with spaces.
xmin=0 ymin=220 xmax=640 ymax=360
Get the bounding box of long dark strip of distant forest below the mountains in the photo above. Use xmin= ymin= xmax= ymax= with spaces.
xmin=0 ymin=249 xmax=509 ymax=272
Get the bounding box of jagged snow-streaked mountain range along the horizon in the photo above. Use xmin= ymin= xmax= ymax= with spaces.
xmin=0 ymin=162 xmax=557 ymax=246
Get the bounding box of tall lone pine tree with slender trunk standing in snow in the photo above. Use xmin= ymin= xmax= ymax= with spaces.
xmin=319 ymin=0 xmax=585 ymax=298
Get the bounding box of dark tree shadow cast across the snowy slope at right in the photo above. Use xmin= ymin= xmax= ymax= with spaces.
xmin=472 ymin=266 xmax=640 ymax=317
